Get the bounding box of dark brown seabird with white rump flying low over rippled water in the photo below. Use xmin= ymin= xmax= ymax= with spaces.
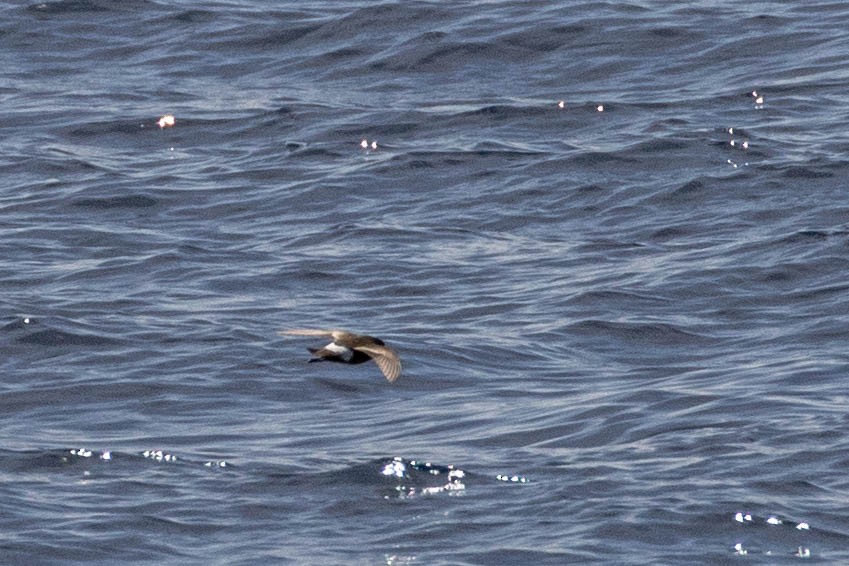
xmin=279 ymin=328 xmax=401 ymax=383
